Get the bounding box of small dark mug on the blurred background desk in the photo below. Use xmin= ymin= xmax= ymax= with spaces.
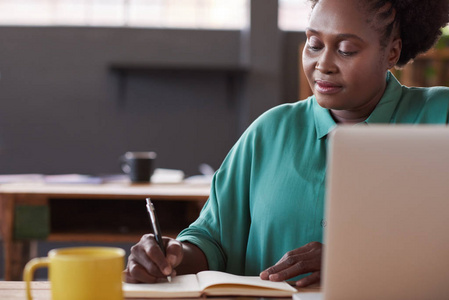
xmin=121 ymin=152 xmax=157 ymax=183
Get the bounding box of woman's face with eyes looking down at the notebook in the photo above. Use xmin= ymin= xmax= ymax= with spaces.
xmin=303 ymin=0 xmax=400 ymax=121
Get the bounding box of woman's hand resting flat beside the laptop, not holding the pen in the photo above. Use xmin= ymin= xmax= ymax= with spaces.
xmin=260 ymin=242 xmax=323 ymax=287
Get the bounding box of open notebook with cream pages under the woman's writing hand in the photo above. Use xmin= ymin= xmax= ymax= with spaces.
xmin=123 ymin=271 xmax=297 ymax=298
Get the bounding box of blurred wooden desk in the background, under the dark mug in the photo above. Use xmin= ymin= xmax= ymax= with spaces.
xmin=0 ymin=183 xmax=210 ymax=282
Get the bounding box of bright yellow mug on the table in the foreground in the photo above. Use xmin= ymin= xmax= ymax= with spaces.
xmin=23 ymin=247 xmax=125 ymax=300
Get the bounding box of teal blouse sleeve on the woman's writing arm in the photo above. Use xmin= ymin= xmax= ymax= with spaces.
xmin=177 ymin=126 xmax=256 ymax=274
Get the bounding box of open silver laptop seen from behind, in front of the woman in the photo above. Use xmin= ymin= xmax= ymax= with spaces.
xmin=294 ymin=125 xmax=449 ymax=300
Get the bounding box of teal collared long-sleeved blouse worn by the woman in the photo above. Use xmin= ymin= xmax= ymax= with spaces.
xmin=178 ymin=73 xmax=449 ymax=275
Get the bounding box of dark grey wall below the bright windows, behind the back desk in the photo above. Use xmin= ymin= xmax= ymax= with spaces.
xmin=0 ymin=27 xmax=245 ymax=173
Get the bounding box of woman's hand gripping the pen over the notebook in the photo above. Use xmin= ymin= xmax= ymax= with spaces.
xmin=123 ymin=234 xmax=184 ymax=283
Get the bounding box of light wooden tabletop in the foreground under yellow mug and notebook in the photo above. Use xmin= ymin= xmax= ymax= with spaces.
xmin=0 ymin=281 xmax=321 ymax=300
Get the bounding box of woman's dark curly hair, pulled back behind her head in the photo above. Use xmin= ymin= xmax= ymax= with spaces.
xmin=309 ymin=0 xmax=449 ymax=67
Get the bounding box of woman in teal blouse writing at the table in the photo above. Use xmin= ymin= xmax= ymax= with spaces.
xmin=124 ymin=0 xmax=449 ymax=286
